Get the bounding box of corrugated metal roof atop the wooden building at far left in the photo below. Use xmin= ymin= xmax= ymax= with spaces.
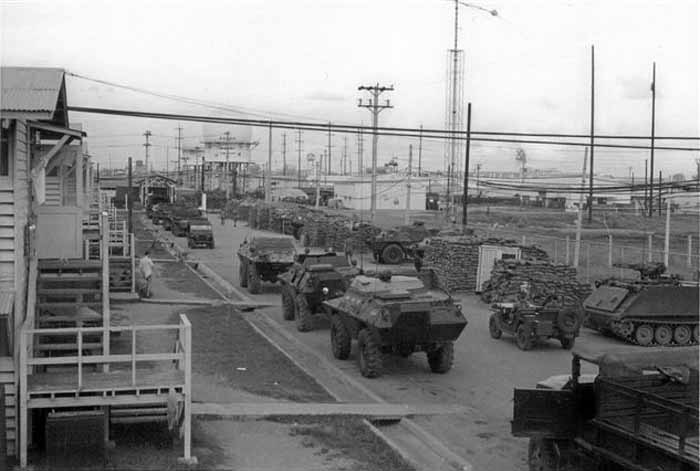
xmin=0 ymin=67 xmax=64 ymax=113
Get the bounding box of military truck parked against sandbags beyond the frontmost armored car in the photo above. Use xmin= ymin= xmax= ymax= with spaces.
xmin=371 ymin=221 xmax=439 ymax=265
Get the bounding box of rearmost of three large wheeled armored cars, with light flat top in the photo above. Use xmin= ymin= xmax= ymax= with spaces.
xmin=237 ymin=233 xmax=296 ymax=294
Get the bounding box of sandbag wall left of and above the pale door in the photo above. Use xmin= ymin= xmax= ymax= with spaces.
xmin=423 ymin=236 xmax=549 ymax=292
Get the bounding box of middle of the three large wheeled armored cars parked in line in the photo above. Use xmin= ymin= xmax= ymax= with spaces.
xmin=278 ymin=248 xmax=360 ymax=332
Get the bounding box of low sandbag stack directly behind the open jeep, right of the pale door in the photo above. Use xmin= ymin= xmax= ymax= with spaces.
xmin=481 ymin=260 xmax=592 ymax=305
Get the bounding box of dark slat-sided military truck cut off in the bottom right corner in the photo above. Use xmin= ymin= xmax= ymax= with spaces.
xmin=511 ymin=346 xmax=699 ymax=471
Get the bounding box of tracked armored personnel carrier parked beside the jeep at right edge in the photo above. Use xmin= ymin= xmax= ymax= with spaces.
xmin=583 ymin=264 xmax=700 ymax=347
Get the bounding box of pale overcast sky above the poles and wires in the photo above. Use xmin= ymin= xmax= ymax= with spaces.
xmin=0 ymin=0 xmax=700 ymax=178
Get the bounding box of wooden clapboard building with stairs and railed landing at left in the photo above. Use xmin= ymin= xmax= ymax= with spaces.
xmin=0 ymin=67 xmax=191 ymax=467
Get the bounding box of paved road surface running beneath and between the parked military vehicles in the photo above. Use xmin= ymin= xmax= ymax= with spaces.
xmin=179 ymin=218 xmax=636 ymax=470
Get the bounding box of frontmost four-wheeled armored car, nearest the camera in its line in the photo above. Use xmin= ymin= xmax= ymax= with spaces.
xmin=323 ymin=272 xmax=467 ymax=378
